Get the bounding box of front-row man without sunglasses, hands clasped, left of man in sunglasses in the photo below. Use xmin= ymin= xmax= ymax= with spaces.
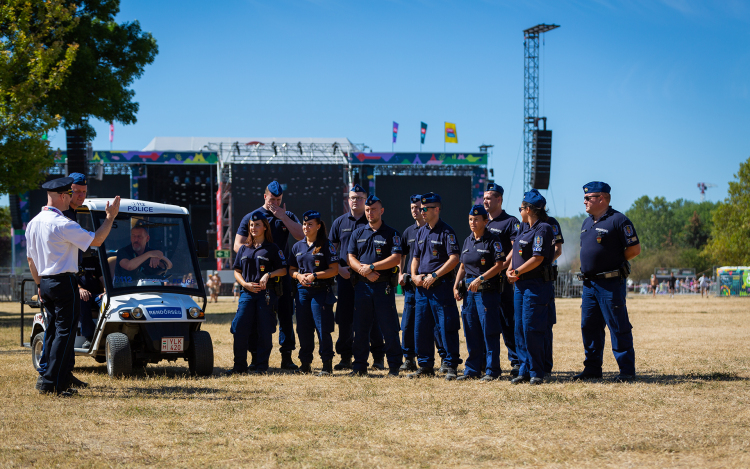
xmin=347 ymin=195 xmax=402 ymax=376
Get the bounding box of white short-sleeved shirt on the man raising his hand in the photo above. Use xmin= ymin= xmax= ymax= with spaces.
xmin=26 ymin=207 xmax=94 ymax=276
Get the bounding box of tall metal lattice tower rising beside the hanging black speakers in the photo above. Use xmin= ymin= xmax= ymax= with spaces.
xmin=523 ymin=24 xmax=560 ymax=192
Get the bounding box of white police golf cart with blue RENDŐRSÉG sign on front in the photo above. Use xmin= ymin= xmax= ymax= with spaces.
xmin=21 ymin=199 xmax=214 ymax=376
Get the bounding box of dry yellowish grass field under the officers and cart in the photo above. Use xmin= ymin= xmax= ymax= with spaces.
xmin=0 ymin=296 xmax=750 ymax=468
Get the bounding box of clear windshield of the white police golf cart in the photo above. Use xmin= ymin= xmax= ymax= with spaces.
xmin=91 ymin=211 xmax=202 ymax=296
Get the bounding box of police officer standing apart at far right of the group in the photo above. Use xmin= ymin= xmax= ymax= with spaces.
xmin=573 ymin=181 xmax=641 ymax=382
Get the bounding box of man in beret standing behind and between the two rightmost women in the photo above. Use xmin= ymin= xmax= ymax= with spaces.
xmin=483 ymin=183 xmax=521 ymax=376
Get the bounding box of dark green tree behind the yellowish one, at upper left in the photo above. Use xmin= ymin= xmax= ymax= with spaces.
xmin=45 ymin=0 xmax=158 ymax=140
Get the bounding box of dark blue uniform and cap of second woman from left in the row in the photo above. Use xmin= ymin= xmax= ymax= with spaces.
xmin=289 ymin=211 xmax=339 ymax=373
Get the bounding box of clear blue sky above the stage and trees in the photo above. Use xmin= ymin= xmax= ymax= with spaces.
xmin=4 ymin=0 xmax=750 ymax=216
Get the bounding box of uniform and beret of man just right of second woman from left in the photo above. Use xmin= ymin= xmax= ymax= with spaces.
xmin=328 ymin=184 xmax=385 ymax=369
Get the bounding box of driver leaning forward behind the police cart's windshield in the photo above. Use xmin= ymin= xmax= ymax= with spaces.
xmin=113 ymin=223 xmax=172 ymax=286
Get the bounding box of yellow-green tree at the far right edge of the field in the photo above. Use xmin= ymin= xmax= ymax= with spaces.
xmin=704 ymin=158 xmax=750 ymax=265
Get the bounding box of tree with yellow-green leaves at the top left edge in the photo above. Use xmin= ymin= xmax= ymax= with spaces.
xmin=0 ymin=0 xmax=78 ymax=193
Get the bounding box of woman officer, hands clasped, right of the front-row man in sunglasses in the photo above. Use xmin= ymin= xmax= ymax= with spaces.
xmin=453 ymin=205 xmax=505 ymax=382
